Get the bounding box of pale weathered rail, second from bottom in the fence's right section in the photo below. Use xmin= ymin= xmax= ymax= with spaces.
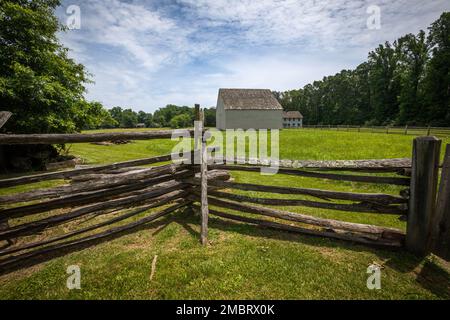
xmin=200 ymin=196 xmax=404 ymax=239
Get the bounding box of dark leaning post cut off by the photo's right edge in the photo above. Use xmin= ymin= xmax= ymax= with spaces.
xmin=431 ymin=144 xmax=450 ymax=261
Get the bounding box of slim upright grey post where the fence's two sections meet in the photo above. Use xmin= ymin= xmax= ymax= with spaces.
xmin=200 ymin=107 xmax=209 ymax=246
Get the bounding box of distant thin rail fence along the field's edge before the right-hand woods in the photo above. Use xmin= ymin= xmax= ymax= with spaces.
xmin=303 ymin=125 xmax=450 ymax=137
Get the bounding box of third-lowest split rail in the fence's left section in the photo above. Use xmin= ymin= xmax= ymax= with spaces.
xmin=0 ymin=182 xmax=185 ymax=240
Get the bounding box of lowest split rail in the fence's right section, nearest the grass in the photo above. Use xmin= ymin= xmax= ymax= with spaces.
xmin=199 ymin=206 xmax=402 ymax=248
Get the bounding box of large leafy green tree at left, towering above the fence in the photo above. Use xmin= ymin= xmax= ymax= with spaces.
xmin=0 ymin=0 xmax=105 ymax=133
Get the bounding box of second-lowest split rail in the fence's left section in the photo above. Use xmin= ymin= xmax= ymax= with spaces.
xmin=0 ymin=190 xmax=189 ymax=256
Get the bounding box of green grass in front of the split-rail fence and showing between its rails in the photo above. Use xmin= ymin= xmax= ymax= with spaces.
xmin=0 ymin=130 xmax=450 ymax=299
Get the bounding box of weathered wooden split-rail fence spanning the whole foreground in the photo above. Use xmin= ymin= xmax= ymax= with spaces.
xmin=0 ymin=105 xmax=450 ymax=273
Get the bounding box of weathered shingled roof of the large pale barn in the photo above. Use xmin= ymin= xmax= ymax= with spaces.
xmin=219 ymin=89 xmax=283 ymax=110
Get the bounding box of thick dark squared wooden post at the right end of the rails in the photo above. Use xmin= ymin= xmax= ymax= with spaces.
xmin=406 ymin=137 xmax=441 ymax=255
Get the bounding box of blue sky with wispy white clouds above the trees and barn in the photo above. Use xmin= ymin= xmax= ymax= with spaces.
xmin=57 ymin=0 xmax=450 ymax=112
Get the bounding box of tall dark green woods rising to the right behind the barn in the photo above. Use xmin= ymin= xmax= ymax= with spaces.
xmin=275 ymin=12 xmax=450 ymax=126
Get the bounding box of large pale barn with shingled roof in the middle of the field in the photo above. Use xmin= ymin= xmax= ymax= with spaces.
xmin=216 ymin=89 xmax=283 ymax=130
